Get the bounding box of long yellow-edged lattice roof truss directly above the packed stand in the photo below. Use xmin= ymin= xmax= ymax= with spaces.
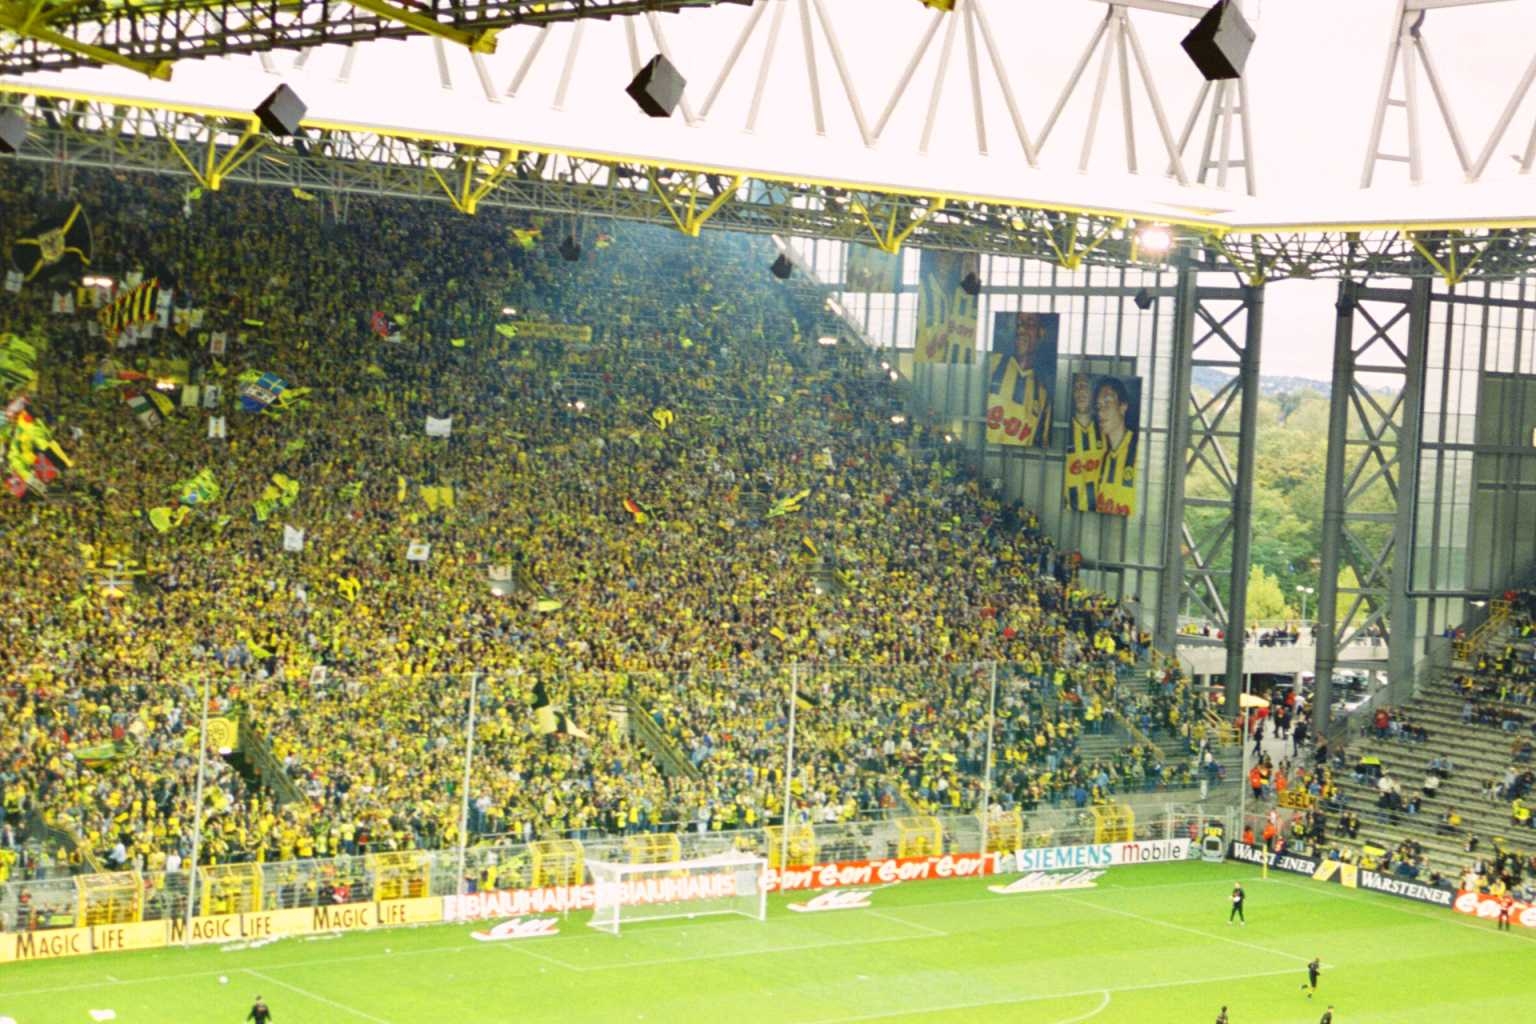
xmin=0 ymin=84 xmax=1536 ymax=282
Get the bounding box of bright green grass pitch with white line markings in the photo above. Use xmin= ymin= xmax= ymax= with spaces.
xmin=0 ymin=863 xmax=1536 ymax=1024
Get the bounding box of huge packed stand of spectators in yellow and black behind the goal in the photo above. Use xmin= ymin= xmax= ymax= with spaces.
xmin=0 ymin=166 xmax=1222 ymax=902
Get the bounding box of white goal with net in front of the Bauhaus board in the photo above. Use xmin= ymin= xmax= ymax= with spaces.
xmin=587 ymin=852 xmax=768 ymax=935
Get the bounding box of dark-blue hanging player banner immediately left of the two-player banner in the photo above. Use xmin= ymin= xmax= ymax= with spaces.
xmin=986 ymin=313 xmax=1061 ymax=448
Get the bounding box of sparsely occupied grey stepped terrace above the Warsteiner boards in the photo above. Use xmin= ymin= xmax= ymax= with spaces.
xmin=1308 ymin=626 xmax=1536 ymax=878
